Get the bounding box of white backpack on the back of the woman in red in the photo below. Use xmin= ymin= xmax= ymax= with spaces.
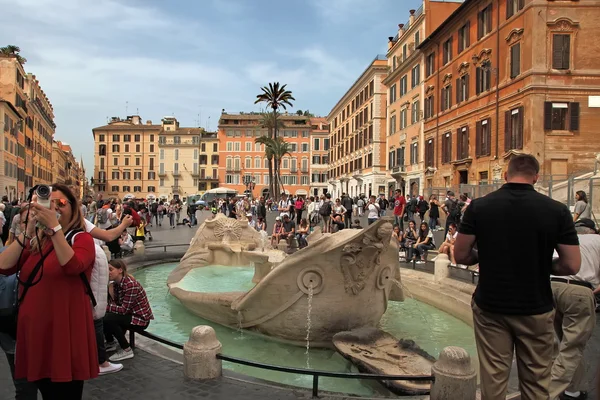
xmin=65 ymin=229 xmax=108 ymax=320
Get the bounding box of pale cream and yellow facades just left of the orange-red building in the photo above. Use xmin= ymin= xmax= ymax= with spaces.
xmin=158 ymin=117 xmax=219 ymax=200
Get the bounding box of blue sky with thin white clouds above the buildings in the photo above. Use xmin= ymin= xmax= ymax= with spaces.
xmin=0 ymin=0 xmax=421 ymax=176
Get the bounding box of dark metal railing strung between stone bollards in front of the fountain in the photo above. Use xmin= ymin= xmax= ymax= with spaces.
xmin=129 ymin=331 xmax=435 ymax=398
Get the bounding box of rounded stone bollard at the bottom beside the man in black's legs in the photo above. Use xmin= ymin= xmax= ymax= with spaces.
xmin=430 ymin=346 xmax=477 ymax=400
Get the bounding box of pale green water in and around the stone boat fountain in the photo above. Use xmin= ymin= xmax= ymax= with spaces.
xmin=134 ymin=263 xmax=476 ymax=397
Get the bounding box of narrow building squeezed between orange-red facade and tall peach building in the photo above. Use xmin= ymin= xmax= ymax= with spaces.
xmin=309 ymin=117 xmax=329 ymax=196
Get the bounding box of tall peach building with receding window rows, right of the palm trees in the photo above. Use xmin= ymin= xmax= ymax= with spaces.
xmin=327 ymin=56 xmax=389 ymax=197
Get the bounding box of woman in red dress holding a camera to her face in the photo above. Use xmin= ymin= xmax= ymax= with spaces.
xmin=0 ymin=184 xmax=99 ymax=400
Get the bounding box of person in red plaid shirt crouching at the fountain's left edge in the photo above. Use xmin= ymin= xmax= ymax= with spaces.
xmin=104 ymin=259 xmax=154 ymax=361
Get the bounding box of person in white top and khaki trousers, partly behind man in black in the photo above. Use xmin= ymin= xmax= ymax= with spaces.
xmin=549 ymin=218 xmax=600 ymax=399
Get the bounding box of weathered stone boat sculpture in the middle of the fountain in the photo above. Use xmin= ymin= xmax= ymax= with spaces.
xmin=167 ymin=214 xmax=404 ymax=346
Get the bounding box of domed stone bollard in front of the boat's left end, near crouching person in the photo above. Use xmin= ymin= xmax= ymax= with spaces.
xmin=183 ymin=325 xmax=223 ymax=380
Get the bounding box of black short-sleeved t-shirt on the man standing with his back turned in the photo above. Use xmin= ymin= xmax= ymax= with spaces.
xmin=459 ymin=183 xmax=579 ymax=315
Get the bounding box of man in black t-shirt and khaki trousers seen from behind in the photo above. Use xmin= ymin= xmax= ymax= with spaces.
xmin=454 ymin=154 xmax=581 ymax=399
